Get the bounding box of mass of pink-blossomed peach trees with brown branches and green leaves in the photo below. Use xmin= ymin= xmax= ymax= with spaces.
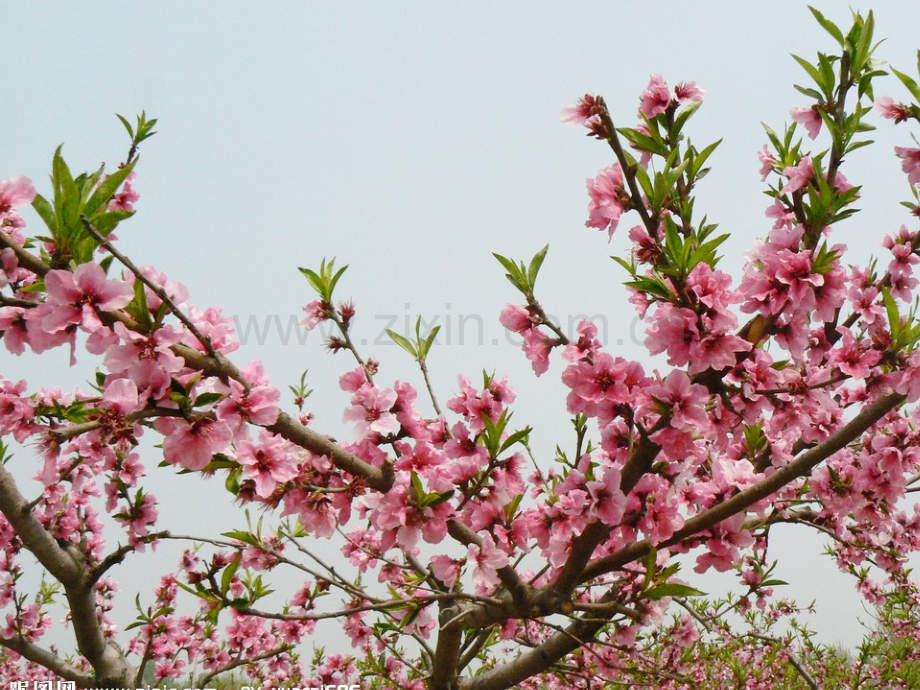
xmin=0 ymin=10 xmax=920 ymax=690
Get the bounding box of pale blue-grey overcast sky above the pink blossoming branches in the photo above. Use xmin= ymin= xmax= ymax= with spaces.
xmin=0 ymin=0 xmax=920 ymax=652
